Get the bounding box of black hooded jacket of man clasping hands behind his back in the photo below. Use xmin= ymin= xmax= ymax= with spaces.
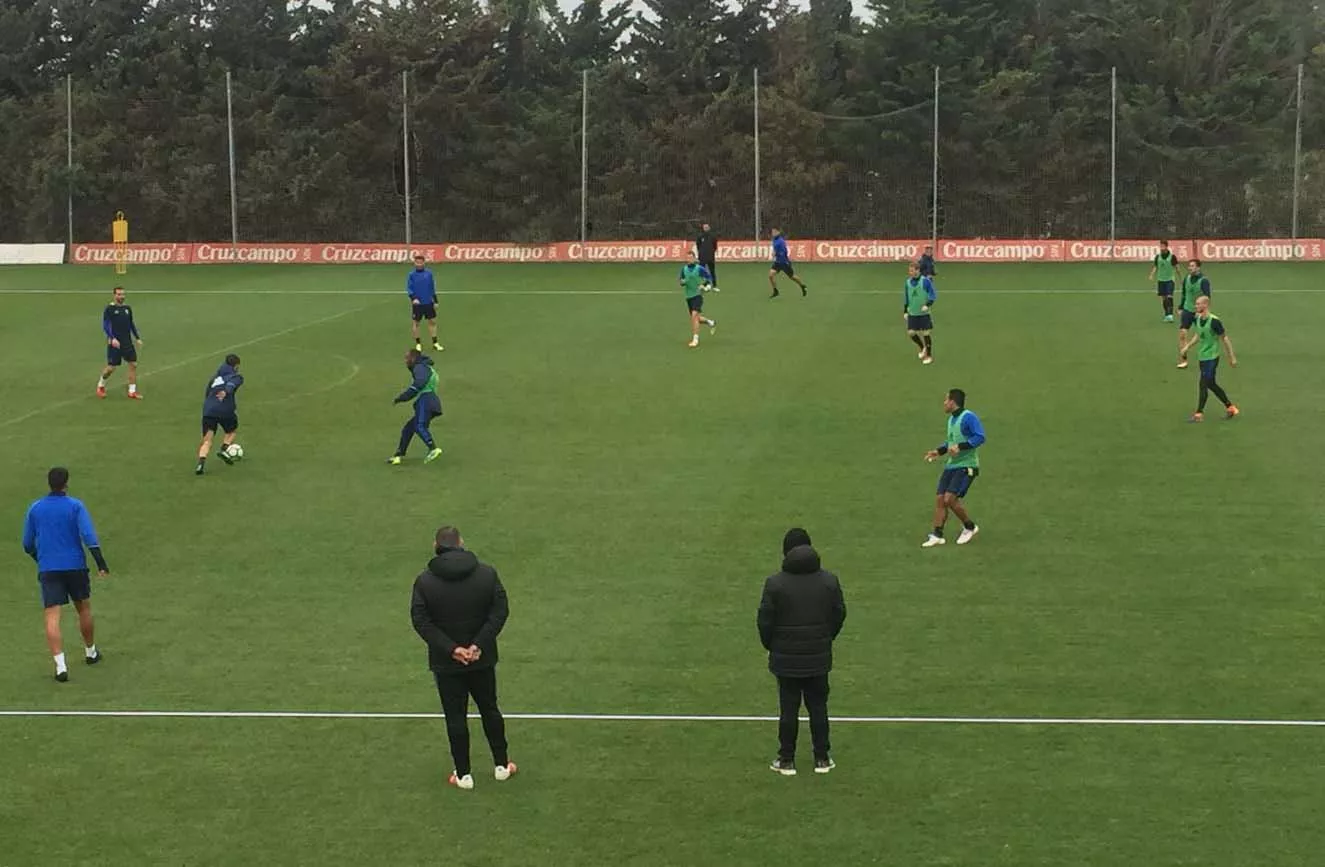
xmin=409 ymin=548 xmax=510 ymax=675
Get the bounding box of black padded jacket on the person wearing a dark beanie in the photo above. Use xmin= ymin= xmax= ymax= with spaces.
xmin=758 ymin=545 xmax=847 ymax=677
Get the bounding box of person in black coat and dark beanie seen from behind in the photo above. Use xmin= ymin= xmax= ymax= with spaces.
xmin=758 ymin=528 xmax=847 ymax=777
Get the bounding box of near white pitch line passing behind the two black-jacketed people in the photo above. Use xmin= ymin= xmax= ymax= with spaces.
xmin=0 ymin=709 xmax=1325 ymax=728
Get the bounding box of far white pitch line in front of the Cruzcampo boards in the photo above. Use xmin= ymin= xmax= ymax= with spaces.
xmin=0 ymin=286 xmax=1325 ymax=298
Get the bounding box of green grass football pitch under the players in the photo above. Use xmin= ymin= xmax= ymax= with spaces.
xmin=0 ymin=265 xmax=1325 ymax=867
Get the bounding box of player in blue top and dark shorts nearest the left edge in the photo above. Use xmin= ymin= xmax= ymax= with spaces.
xmin=23 ymin=467 xmax=110 ymax=683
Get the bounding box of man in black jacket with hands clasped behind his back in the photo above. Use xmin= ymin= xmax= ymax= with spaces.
xmin=409 ymin=526 xmax=515 ymax=789
